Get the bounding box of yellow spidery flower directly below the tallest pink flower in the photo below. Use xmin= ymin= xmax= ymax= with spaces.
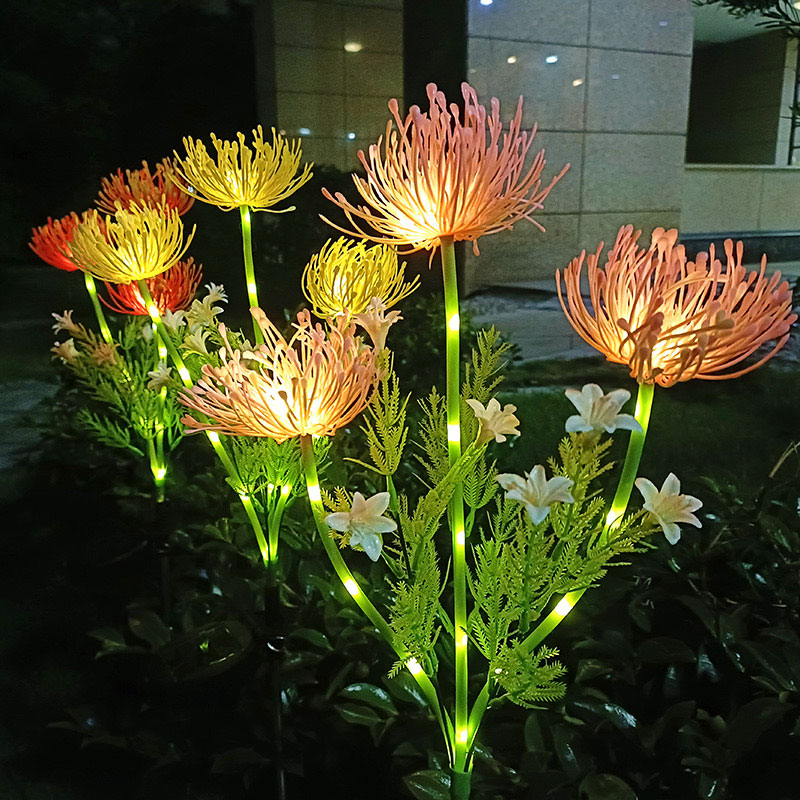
xmin=303 ymin=236 xmax=419 ymax=317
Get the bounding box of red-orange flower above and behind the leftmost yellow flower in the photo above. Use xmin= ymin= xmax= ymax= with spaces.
xmin=95 ymin=158 xmax=194 ymax=216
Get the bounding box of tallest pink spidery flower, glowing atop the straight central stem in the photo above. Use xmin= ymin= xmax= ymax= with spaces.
xmin=322 ymin=83 xmax=569 ymax=254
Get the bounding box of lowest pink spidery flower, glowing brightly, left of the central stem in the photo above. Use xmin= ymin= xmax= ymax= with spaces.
xmin=180 ymin=308 xmax=376 ymax=442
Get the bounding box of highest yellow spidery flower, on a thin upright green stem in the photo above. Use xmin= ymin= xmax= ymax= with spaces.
xmin=175 ymin=125 xmax=313 ymax=211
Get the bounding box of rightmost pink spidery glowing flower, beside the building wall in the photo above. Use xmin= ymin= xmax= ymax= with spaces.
xmin=556 ymin=225 xmax=797 ymax=386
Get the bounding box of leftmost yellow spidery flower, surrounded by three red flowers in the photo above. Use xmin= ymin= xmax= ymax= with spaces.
xmin=71 ymin=204 xmax=195 ymax=283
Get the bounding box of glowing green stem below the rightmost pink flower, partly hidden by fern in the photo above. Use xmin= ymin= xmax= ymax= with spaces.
xmin=523 ymin=383 xmax=654 ymax=651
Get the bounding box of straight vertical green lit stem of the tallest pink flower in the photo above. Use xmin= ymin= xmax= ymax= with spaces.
xmin=441 ymin=236 xmax=469 ymax=773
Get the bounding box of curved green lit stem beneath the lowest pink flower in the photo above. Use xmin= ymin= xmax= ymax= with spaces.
xmin=300 ymin=435 xmax=453 ymax=753
